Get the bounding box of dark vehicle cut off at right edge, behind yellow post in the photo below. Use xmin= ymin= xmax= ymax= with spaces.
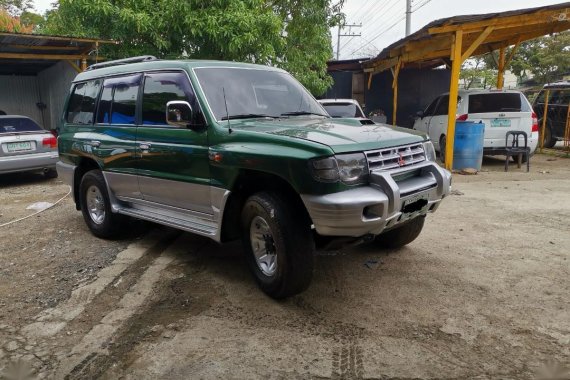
xmin=532 ymin=81 xmax=570 ymax=148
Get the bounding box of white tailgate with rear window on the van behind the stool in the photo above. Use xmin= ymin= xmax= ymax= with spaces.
xmin=467 ymin=92 xmax=532 ymax=147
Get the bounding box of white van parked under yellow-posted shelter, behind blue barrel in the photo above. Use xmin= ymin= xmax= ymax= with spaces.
xmin=413 ymin=89 xmax=538 ymax=161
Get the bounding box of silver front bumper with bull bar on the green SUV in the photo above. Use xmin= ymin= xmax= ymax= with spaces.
xmin=301 ymin=161 xmax=451 ymax=237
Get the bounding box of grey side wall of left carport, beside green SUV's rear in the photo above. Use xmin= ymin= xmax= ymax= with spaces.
xmin=37 ymin=61 xmax=77 ymax=129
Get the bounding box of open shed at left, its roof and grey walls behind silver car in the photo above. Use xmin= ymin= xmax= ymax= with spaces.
xmin=0 ymin=32 xmax=115 ymax=129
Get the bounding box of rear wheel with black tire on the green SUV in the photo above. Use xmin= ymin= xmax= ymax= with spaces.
xmin=79 ymin=170 xmax=127 ymax=239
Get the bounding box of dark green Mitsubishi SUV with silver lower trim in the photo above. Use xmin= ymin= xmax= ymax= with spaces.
xmin=57 ymin=57 xmax=451 ymax=298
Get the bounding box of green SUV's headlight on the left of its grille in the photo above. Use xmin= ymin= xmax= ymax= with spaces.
xmin=310 ymin=153 xmax=368 ymax=185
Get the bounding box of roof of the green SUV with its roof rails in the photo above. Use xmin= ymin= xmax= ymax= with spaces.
xmin=74 ymin=59 xmax=286 ymax=82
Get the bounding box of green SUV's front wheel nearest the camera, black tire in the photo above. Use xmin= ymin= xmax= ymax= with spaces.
xmin=241 ymin=192 xmax=315 ymax=299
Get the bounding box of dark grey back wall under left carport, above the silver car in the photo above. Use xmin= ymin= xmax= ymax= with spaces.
xmin=0 ymin=75 xmax=44 ymax=125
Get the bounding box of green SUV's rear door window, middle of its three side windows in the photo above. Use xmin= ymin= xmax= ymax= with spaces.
xmin=97 ymin=74 xmax=142 ymax=125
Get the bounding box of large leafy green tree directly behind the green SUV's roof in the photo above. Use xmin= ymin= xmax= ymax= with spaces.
xmin=43 ymin=0 xmax=344 ymax=95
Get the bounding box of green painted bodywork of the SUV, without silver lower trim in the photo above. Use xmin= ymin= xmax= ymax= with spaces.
xmin=59 ymin=60 xmax=427 ymax=199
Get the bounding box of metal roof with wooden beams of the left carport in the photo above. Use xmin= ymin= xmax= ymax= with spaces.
xmin=0 ymin=32 xmax=115 ymax=75
